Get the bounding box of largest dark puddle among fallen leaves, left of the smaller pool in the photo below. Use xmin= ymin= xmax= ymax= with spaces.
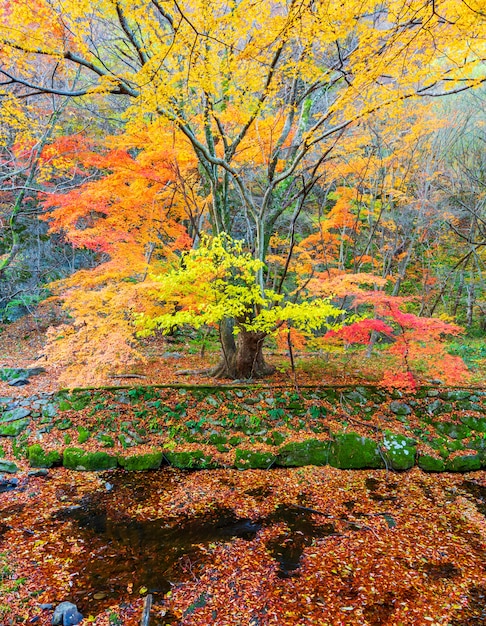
xmin=55 ymin=493 xmax=261 ymax=612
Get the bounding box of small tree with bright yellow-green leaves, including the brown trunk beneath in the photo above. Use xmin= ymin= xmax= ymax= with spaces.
xmin=138 ymin=234 xmax=345 ymax=378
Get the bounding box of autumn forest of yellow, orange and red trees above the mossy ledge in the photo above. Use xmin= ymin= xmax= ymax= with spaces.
xmin=0 ymin=0 xmax=486 ymax=386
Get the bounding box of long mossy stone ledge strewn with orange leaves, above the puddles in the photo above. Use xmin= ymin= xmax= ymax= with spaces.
xmin=5 ymin=384 xmax=486 ymax=472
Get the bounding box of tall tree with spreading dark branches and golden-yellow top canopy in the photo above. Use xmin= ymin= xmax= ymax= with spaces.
xmin=0 ymin=0 xmax=485 ymax=375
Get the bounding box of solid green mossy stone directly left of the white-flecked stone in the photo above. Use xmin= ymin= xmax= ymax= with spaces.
xmin=329 ymin=433 xmax=385 ymax=469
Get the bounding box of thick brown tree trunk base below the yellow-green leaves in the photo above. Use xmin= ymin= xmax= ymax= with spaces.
xmin=211 ymin=320 xmax=275 ymax=379
